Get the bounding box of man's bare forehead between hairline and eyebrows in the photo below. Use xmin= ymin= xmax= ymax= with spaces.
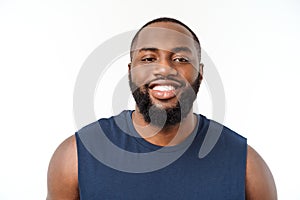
xmin=133 ymin=22 xmax=196 ymax=52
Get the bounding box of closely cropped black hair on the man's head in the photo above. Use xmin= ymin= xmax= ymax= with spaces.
xmin=130 ymin=17 xmax=201 ymax=62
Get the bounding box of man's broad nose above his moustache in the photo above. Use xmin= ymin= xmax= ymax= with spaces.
xmin=154 ymin=59 xmax=177 ymax=76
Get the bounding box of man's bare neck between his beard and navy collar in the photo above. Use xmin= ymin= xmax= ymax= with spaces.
xmin=132 ymin=110 xmax=197 ymax=146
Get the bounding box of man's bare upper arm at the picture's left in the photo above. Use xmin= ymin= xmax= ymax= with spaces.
xmin=47 ymin=135 xmax=79 ymax=200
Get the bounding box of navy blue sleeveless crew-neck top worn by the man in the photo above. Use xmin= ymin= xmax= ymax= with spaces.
xmin=75 ymin=111 xmax=247 ymax=200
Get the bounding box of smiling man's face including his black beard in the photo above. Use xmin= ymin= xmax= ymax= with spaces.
xmin=129 ymin=22 xmax=202 ymax=126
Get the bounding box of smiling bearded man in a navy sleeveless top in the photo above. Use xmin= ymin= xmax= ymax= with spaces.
xmin=47 ymin=18 xmax=277 ymax=200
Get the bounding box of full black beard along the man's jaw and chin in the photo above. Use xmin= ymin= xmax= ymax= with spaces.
xmin=129 ymin=73 xmax=200 ymax=128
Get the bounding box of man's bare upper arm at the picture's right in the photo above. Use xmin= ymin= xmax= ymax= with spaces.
xmin=246 ymin=146 xmax=277 ymax=200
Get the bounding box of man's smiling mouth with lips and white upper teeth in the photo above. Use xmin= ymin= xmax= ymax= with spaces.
xmin=149 ymin=80 xmax=183 ymax=100
